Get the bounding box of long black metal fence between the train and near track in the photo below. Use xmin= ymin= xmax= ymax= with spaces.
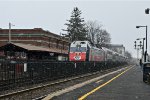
xmin=0 ymin=61 xmax=126 ymax=91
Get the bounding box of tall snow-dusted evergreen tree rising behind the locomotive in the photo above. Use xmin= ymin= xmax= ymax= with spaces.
xmin=64 ymin=7 xmax=86 ymax=41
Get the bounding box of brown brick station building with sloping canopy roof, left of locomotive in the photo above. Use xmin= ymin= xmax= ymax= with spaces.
xmin=0 ymin=28 xmax=69 ymax=60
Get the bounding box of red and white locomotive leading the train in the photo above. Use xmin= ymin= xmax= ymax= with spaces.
xmin=69 ymin=41 xmax=105 ymax=61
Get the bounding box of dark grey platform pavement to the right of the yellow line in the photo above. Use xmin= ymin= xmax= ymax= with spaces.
xmin=83 ymin=66 xmax=150 ymax=100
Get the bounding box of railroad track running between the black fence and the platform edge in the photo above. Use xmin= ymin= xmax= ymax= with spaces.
xmin=0 ymin=67 xmax=128 ymax=100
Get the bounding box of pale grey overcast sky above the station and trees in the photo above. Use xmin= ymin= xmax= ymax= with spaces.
xmin=0 ymin=0 xmax=150 ymax=57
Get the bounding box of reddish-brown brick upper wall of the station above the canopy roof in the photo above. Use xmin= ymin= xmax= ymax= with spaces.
xmin=0 ymin=28 xmax=69 ymax=50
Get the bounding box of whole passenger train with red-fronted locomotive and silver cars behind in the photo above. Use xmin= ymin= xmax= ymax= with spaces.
xmin=69 ymin=41 xmax=127 ymax=61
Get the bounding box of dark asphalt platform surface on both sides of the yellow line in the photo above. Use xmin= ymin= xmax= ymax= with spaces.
xmin=46 ymin=66 xmax=150 ymax=100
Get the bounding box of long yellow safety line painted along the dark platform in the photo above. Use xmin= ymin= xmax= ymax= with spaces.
xmin=78 ymin=67 xmax=132 ymax=100
